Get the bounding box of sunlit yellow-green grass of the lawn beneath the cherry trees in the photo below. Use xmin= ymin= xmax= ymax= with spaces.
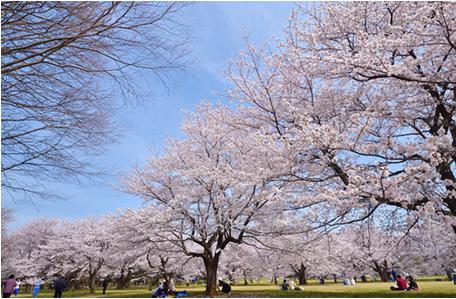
xmin=12 ymin=281 xmax=456 ymax=298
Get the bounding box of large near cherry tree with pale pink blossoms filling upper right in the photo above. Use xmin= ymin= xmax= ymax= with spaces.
xmin=228 ymin=2 xmax=456 ymax=233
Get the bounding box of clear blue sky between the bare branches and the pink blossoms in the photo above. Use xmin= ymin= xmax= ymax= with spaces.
xmin=2 ymin=2 xmax=294 ymax=228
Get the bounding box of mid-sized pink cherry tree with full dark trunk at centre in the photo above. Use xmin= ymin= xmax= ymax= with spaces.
xmin=123 ymin=105 xmax=284 ymax=295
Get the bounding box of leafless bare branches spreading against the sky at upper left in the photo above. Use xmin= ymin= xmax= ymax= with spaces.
xmin=1 ymin=2 xmax=188 ymax=202
